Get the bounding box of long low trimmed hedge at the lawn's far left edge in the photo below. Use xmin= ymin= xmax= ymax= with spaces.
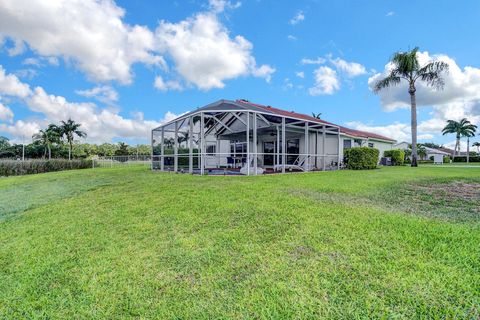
xmin=0 ymin=159 xmax=92 ymax=176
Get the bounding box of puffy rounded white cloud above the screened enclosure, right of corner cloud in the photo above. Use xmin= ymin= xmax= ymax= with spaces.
xmin=155 ymin=13 xmax=274 ymax=90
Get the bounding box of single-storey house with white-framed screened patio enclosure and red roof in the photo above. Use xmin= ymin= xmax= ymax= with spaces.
xmin=151 ymin=100 xmax=395 ymax=175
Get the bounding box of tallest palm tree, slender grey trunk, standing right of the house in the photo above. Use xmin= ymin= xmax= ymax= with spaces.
xmin=374 ymin=48 xmax=448 ymax=167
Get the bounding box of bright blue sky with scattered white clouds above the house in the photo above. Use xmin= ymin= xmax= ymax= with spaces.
xmin=0 ymin=0 xmax=480 ymax=147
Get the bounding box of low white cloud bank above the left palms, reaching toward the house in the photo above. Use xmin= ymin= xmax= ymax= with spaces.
xmin=0 ymin=66 xmax=174 ymax=142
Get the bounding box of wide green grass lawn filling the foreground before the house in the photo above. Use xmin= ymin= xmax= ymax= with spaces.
xmin=0 ymin=166 xmax=480 ymax=319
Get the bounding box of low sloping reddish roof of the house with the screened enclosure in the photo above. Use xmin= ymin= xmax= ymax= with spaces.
xmin=155 ymin=99 xmax=396 ymax=142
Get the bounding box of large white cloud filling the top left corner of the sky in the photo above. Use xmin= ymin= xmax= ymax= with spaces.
xmin=0 ymin=0 xmax=164 ymax=83
